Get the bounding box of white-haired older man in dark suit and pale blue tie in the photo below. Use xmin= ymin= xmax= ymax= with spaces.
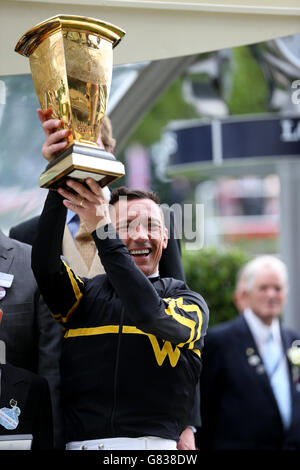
xmin=200 ymin=256 xmax=300 ymax=451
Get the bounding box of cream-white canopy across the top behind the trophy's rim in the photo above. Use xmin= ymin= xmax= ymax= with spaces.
xmin=0 ymin=0 xmax=300 ymax=75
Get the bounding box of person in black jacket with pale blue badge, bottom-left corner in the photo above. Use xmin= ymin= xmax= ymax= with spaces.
xmin=0 ymin=310 xmax=53 ymax=450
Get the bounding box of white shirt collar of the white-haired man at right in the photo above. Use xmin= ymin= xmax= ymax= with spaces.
xmin=243 ymin=308 xmax=282 ymax=355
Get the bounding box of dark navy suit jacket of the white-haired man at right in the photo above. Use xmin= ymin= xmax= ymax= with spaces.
xmin=199 ymin=315 xmax=300 ymax=451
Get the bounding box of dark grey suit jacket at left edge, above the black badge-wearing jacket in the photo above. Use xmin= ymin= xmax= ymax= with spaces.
xmin=0 ymin=231 xmax=62 ymax=448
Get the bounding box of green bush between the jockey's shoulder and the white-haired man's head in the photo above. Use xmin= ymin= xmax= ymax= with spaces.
xmin=182 ymin=247 xmax=250 ymax=326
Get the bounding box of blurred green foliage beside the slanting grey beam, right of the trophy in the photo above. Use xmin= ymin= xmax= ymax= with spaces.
xmin=127 ymin=78 xmax=199 ymax=147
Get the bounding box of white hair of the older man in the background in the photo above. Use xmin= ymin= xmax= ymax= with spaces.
xmin=240 ymin=255 xmax=288 ymax=292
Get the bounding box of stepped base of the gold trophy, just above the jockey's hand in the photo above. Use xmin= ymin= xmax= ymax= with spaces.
xmin=39 ymin=142 xmax=125 ymax=189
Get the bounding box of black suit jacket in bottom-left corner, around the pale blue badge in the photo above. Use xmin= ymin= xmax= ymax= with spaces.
xmin=0 ymin=364 xmax=53 ymax=450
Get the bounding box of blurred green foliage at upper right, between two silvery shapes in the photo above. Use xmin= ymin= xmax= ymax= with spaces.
xmin=224 ymin=46 xmax=269 ymax=114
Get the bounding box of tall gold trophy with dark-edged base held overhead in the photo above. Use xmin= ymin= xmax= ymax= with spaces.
xmin=15 ymin=15 xmax=125 ymax=189
